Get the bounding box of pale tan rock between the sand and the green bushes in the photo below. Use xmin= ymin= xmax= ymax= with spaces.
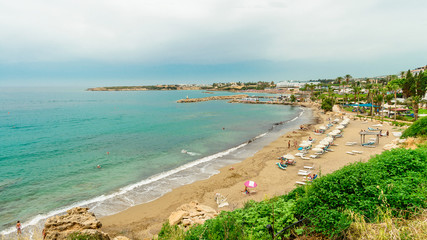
xmin=169 ymin=201 xmax=218 ymax=228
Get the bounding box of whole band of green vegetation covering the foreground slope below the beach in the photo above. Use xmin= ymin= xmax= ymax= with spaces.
xmin=159 ymin=148 xmax=427 ymax=239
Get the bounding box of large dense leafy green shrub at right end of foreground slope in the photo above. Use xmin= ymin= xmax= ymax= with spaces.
xmin=289 ymin=149 xmax=427 ymax=237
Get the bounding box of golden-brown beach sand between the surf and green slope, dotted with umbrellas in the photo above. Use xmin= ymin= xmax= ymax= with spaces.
xmin=100 ymin=106 xmax=395 ymax=239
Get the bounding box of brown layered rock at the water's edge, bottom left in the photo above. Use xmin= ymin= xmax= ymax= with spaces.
xmin=43 ymin=207 xmax=110 ymax=240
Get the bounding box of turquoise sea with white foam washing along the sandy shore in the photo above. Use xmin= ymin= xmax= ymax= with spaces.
xmin=0 ymin=88 xmax=312 ymax=238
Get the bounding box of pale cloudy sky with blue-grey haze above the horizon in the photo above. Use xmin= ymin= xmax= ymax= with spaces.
xmin=0 ymin=0 xmax=427 ymax=87
